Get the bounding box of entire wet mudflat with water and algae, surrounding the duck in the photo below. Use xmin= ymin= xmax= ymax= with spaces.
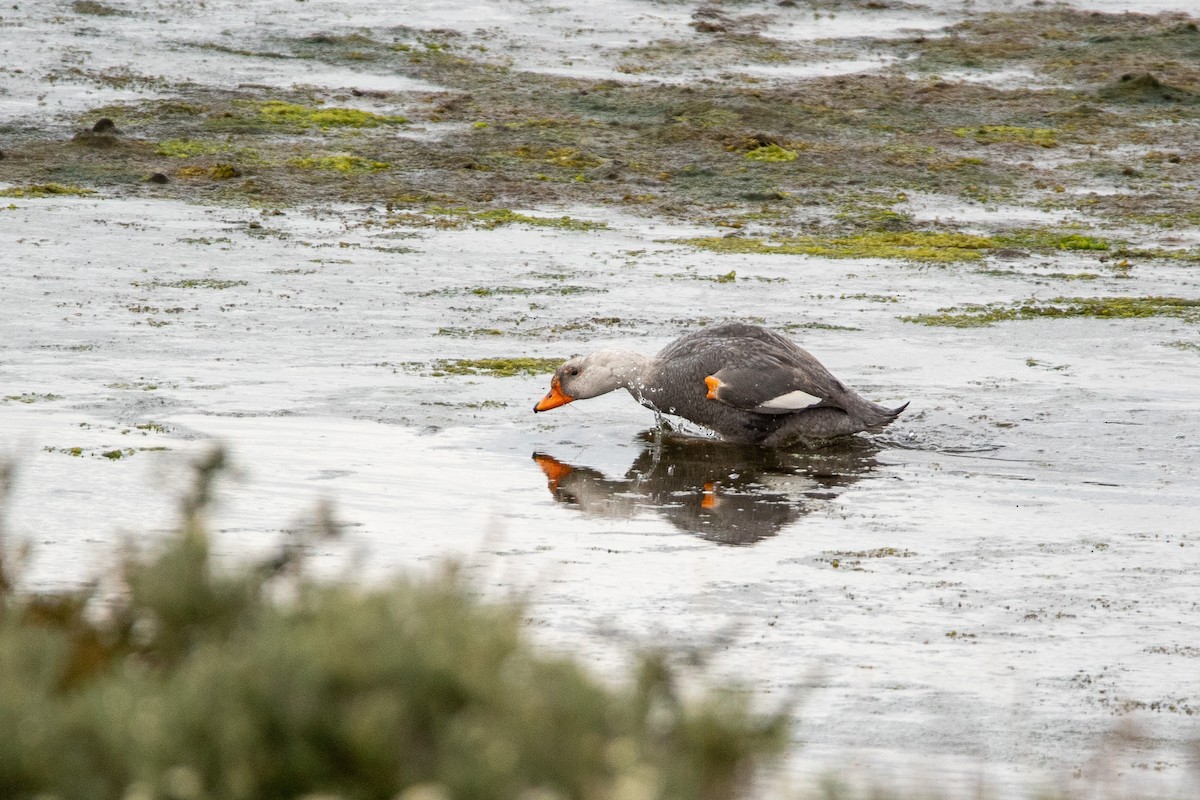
xmin=0 ymin=0 xmax=1200 ymax=796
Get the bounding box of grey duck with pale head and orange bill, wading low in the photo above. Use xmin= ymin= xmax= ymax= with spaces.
xmin=533 ymin=321 xmax=908 ymax=447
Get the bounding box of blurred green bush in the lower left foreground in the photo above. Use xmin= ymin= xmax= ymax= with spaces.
xmin=0 ymin=453 xmax=787 ymax=800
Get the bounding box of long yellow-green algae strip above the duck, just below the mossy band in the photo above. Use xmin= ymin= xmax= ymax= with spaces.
xmin=673 ymin=231 xmax=996 ymax=263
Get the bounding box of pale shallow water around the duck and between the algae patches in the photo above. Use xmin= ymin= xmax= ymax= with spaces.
xmin=0 ymin=1 xmax=1200 ymax=796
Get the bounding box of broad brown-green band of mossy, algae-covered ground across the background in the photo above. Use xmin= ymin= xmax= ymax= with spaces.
xmin=0 ymin=4 xmax=1200 ymax=250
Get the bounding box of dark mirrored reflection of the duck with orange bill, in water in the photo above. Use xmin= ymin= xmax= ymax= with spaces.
xmin=533 ymin=434 xmax=878 ymax=545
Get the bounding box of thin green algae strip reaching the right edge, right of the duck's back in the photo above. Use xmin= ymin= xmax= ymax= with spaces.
xmin=900 ymin=296 xmax=1200 ymax=327
